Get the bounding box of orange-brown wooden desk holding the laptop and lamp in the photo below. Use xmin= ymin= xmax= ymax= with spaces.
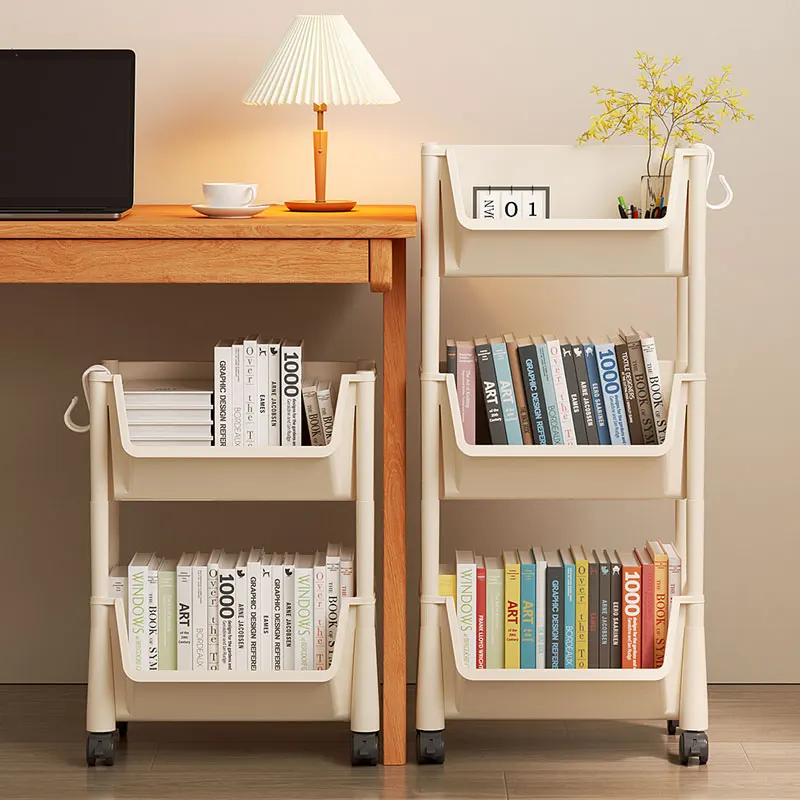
xmin=0 ymin=206 xmax=417 ymax=764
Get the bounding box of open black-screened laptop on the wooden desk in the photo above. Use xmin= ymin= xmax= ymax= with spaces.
xmin=0 ymin=50 xmax=136 ymax=220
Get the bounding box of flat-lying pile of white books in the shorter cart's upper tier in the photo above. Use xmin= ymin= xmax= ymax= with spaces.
xmin=124 ymin=380 xmax=212 ymax=447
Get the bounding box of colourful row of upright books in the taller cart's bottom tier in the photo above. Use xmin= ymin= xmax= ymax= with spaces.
xmin=439 ymin=541 xmax=682 ymax=669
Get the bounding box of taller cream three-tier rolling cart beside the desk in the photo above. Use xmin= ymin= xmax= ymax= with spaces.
xmin=416 ymin=144 xmax=730 ymax=763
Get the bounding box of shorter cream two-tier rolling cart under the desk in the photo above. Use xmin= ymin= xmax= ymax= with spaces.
xmin=66 ymin=362 xmax=380 ymax=765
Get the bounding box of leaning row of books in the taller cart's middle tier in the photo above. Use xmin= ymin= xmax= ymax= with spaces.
xmin=447 ymin=330 xmax=667 ymax=445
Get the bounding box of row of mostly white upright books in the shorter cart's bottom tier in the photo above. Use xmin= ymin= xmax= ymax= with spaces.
xmin=109 ymin=544 xmax=355 ymax=672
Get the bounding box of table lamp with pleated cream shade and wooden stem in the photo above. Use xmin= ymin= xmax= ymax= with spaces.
xmin=242 ymin=14 xmax=400 ymax=211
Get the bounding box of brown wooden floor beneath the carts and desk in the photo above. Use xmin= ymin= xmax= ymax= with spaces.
xmin=0 ymin=686 xmax=800 ymax=800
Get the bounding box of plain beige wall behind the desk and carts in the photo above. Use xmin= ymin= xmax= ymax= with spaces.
xmin=0 ymin=0 xmax=800 ymax=681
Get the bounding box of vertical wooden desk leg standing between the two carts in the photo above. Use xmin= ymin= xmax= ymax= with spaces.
xmin=383 ymin=239 xmax=406 ymax=765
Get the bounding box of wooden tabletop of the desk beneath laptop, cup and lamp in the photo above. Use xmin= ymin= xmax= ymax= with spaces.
xmin=0 ymin=205 xmax=417 ymax=239
